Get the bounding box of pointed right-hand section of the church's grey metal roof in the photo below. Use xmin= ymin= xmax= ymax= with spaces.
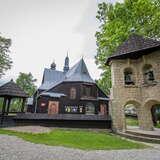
xmin=65 ymin=58 xmax=95 ymax=83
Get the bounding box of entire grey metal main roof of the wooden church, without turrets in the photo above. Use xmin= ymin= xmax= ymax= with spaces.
xmin=39 ymin=58 xmax=95 ymax=90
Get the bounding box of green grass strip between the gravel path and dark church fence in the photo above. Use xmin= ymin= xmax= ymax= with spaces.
xmin=0 ymin=129 xmax=147 ymax=150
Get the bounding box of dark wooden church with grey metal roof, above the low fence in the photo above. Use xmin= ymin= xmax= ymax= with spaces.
xmin=28 ymin=55 xmax=108 ymax=115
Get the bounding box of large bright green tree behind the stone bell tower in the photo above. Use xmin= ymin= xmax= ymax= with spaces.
xmin=96 ymin=0 xmax=160 ymax=93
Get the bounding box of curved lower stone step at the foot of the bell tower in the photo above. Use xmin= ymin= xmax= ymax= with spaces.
xmin=117 ymin=132 xmax=160 ymax=144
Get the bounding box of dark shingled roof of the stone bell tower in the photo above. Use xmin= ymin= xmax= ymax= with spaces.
xmin=107 ymin=34 xmax=160 ymax=64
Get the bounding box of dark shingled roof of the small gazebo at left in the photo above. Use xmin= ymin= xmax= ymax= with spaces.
xmin=0 ymin=80 xmax=28 ymax=98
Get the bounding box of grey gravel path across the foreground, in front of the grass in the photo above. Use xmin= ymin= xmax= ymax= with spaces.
xmin=0 ymin=135 xmax=160 ymax=160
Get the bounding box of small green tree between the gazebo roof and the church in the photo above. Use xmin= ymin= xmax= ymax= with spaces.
xmin=16 ymin=72 xmax=37 ymax=96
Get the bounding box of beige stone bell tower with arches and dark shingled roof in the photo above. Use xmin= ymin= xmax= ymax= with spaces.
xmin=107 ymin=34 xmax=160 ymax=131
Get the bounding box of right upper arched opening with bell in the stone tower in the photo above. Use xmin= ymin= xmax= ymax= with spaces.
xmin=143 ymin=64 xmax=155 ymax=83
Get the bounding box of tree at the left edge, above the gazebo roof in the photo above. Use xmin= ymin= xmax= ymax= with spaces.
xmin=0 ymin=36 xmax=12 ymax=78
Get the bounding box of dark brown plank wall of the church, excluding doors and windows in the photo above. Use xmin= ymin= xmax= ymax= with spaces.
xmin=37 ymin=82 xmax=108 ymax=114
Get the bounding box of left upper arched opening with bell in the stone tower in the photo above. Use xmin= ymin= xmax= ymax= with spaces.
xmin=124 ymin=68 xmax=134 ymax=85
